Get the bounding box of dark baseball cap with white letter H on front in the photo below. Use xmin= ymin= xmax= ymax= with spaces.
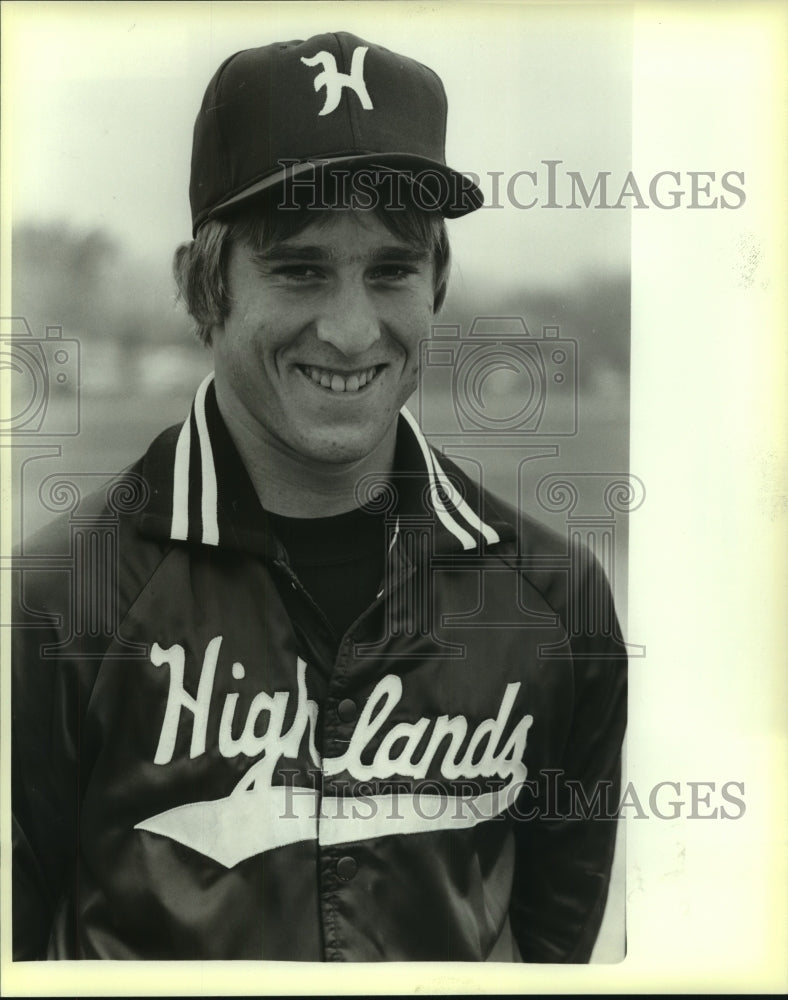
xmin=189 ymin=31 xmax=484 ymax=234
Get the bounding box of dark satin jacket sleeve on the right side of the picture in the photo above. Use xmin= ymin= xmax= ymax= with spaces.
xmin=510 ymin=548 xmax=627 ymax=963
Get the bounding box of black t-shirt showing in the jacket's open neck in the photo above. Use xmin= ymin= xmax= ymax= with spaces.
xmin=268 ymin=507 xmax=386 ymax=645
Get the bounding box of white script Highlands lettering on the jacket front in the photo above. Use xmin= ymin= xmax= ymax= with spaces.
xmin=151 ymin=635 xmax=533 ymax=791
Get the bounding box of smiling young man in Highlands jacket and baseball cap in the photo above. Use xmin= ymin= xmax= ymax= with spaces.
xmin=13 ymin=33 xmax=626 ymax=962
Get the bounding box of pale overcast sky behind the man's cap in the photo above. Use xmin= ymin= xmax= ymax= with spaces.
xmin=4 ymin=2 xmax=631 ymax=286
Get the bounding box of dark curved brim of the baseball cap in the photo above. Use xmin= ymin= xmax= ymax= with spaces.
xmin=194 ymin=153 xmax=484 ymax=234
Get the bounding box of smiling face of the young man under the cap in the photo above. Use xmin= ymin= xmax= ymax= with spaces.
xmin=213 ymin=210 xmax=434 ymax=464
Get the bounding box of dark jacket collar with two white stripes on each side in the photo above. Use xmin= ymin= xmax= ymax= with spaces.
xmin=141 ymin=374 xmax=514 ymax=556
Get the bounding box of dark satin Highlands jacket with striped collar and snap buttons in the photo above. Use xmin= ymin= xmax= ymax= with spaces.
xmin=12 ymin=379 xmax=626 ymax=962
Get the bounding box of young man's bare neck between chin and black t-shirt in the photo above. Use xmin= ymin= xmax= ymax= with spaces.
xmin=219 ymin=392 xmax=397 ymax=517
